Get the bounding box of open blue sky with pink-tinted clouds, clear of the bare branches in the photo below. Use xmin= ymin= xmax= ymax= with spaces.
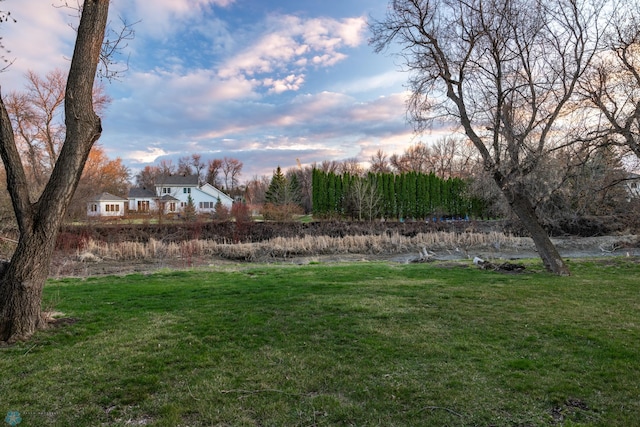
xmin=0 ymin=0 xmax=448 ymax=181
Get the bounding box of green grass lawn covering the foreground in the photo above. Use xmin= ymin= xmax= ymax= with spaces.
xmin=0 ymin=259 xmax=640 ymax=427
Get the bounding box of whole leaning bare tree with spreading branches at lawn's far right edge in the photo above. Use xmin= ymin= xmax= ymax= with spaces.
xmin=372 ymin=0 xmax=603 ymax=275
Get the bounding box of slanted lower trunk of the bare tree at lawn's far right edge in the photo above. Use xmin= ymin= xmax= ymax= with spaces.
xmin=494 ymin=174 xmax=571 ymax=276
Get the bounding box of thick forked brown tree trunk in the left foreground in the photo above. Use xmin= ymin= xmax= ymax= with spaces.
xmin=0 ymin=0 xmax=109 ymax=342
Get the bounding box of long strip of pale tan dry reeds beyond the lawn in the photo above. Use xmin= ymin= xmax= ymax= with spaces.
xmin=77 ymin=232 xmax=533 ymax=262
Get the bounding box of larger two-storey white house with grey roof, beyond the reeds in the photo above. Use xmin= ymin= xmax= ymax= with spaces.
xmin=129 ymin=175 xmax=233 ymax=213
